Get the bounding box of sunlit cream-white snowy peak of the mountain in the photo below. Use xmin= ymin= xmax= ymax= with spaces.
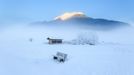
xmin=55 ymin=12 xmax=86 ymax=21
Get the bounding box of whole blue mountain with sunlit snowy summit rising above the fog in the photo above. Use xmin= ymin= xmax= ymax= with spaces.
xmin=31 ymin=12 xmax=129 ymax=30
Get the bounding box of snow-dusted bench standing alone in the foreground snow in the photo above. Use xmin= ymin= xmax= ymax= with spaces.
xmin=53 ymin=52 xmax=67 ymax=62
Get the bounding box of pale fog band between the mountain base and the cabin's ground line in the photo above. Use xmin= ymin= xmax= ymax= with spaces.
xmin=0 ymin=24 xmax=134 ymax=44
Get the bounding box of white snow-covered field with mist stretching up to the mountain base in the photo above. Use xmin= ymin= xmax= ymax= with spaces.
xmin=0 ymin=26 xmax=134 ymax=75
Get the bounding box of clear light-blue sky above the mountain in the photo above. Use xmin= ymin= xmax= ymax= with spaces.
xmin=0 ymin=0 xmax=134 ymax=23
